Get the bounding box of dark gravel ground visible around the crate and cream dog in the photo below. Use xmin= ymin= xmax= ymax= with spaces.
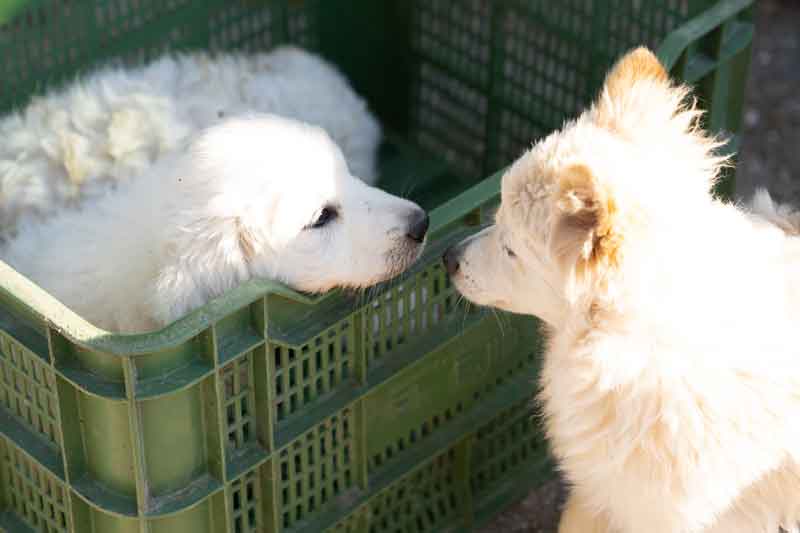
xmin=481 ymin=0 xmax=800 ymax=533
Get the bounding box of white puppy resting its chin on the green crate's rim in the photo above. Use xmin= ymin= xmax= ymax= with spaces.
xmin=2 ymin=115 xmax=428 ymax=333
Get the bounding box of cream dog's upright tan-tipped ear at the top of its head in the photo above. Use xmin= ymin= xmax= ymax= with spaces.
xmin=593 ymin=47 xmax=686 ymax=134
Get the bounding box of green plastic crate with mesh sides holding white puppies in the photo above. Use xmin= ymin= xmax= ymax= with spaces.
xmin=0 ymin=0 xmax=753 ymax=533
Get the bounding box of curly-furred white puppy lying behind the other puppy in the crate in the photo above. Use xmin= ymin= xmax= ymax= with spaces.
xmin=0 ymin=47 xmax=381 ymax=237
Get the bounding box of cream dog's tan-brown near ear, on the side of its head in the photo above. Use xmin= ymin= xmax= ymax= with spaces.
xmin=550 ymin=164 xmax=622 ymax=271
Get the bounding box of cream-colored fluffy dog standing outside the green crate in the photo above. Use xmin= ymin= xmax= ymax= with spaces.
xmin=445 ymin=49 xmax=800 ymax=533
